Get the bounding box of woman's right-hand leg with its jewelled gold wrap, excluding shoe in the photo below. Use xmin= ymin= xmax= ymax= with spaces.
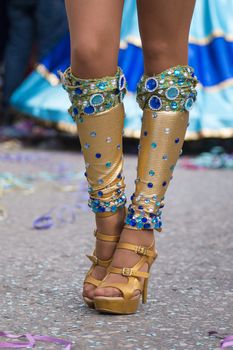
xmin=95 ymin=0 xmax=195 ymax=297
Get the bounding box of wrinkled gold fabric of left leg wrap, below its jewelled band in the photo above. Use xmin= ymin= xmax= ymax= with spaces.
xmin=77 ymin=103 xmax=125 ymax=216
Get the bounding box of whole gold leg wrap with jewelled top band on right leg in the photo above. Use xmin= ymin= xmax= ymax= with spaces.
xmin=126 ymin=66 xmax=197 ymax=231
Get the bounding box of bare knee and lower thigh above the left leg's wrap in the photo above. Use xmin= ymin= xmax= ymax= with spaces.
xmin=66 ymin=0 xmax=124 ymax=79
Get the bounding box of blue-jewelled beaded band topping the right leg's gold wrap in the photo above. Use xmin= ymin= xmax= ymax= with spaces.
xmin=137 ymin=65 xmax=198 ymax=112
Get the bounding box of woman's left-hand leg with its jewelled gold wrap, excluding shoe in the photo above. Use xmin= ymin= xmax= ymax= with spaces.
xmin=62 ymin=0 xmax=125 ymax=299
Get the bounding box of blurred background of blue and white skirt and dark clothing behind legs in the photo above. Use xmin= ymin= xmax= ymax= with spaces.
xmin=0 ymin=0 xmax=233 ymax=159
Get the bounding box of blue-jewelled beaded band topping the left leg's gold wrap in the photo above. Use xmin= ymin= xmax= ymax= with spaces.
xmin=60 ymin=67 xmax=127 ymax=123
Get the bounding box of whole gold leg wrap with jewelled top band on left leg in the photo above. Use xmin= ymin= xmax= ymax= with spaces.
xmin=62 ymin=68 xmax=126 ymax=216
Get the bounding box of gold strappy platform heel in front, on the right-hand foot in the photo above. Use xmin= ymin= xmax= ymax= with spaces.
xmin=94 ymin=241 xmax=157 ymax=314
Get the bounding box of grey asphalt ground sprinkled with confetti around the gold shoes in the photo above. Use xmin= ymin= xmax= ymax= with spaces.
xmin=0 ymin=151 xmax=233 ymax=350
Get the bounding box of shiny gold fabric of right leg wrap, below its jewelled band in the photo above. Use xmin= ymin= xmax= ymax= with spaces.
xmin=126 ymin=109 xmax=189 ymax=231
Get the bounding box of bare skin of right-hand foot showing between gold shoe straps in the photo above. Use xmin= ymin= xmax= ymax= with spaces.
xmin=94 ymin=228 xmax=154 ymax=297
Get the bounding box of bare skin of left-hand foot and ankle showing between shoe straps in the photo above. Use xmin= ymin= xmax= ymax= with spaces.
xmin=83 ymin=208 xmax=125 ymax=299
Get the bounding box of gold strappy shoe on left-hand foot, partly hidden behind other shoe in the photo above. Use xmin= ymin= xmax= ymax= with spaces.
xmin=83 ymin=230 xmax=120 ymax=309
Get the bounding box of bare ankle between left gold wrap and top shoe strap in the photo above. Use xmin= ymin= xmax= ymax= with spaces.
xmin=95 ymin=208 xmax=125 ymax=235
